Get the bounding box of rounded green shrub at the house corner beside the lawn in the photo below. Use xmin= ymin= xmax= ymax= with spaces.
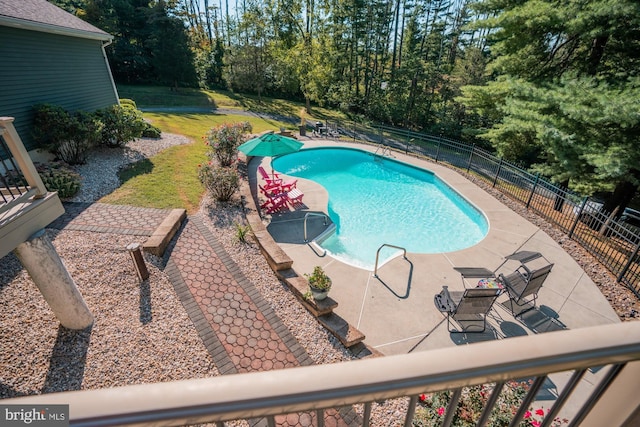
xmin=96 ymin=105 xmax=146 ymax=147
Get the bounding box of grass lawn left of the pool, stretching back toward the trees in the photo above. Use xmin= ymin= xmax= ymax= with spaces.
xmin=100 ymin=85 xmax=352 ymax=214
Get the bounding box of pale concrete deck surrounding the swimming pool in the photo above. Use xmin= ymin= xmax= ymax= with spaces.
xmin=249 ymin=140 xmax=620 ymax=355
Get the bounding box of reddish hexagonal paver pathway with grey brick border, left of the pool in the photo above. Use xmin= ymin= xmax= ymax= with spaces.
xmin=50 ymin=203 xmax=361 ymax=427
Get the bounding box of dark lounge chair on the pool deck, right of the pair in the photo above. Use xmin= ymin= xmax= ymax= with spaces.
xmin=498 ymin=263 xmax=553 ymax=317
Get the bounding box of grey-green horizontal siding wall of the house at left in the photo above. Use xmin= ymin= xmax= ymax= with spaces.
xmin=0 ymin=26 xmax=118 ymax=150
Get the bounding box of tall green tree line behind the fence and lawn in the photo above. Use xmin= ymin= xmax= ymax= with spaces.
xmin=54 ymin=0 xmax=640 ymax=216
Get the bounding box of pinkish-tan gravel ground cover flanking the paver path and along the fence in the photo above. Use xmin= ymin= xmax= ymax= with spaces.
xmin=0 ymin=134 xmax=640 ymax=426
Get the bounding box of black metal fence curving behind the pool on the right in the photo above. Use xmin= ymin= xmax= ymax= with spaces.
xmin=326 ymin=118 xmax=640 ymax=297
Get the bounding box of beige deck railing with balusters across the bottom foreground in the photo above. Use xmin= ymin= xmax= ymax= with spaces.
xmin=2 ymin=322 xmax=640 ymax=427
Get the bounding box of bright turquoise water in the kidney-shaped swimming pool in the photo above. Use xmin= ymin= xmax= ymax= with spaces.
xmin=272 ymin=148 xmax=489 ymax=269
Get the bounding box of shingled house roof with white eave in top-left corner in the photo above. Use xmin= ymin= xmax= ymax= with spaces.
xmin=0 ymin=0 xmax=113 ymax=41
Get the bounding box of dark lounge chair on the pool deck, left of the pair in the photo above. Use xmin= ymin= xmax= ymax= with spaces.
xmin=434 ymin=286 xmax=502 ymax=333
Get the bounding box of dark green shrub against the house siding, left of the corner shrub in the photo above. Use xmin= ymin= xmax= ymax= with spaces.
xmin=33 ymin=104 xmax=102 ymax=165
